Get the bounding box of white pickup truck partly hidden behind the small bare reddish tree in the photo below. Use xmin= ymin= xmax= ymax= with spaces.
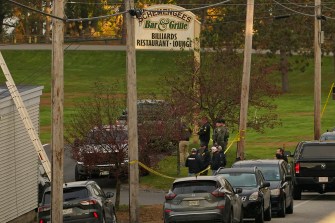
xmin=72 ymin=125 xmax=128 ymax=180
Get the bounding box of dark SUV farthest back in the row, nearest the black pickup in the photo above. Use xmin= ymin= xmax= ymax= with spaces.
xmin=232 ymin=159 xmax=293 ymax=217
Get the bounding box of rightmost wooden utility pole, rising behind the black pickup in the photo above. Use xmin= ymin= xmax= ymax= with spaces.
xmin=314 ymin=0 xmax=321 ymax=140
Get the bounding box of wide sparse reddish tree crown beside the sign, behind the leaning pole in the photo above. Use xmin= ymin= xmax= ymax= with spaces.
xmin=166 ymin=48 xmax=280 ymax=135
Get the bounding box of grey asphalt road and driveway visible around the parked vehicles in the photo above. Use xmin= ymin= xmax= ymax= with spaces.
xmin=45 ymin=145 xmax=335 ymax=223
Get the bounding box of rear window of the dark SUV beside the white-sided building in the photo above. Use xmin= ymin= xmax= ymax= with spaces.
xmin=43 ymin=187 xmax=88 ymax=204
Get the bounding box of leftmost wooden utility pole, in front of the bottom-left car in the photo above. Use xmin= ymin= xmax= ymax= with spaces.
xmin=51 ymin=0 xmax=64 ymax=223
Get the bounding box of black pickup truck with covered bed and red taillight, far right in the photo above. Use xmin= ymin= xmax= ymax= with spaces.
xmin=292 ymin=141 xmax=335 ymax=200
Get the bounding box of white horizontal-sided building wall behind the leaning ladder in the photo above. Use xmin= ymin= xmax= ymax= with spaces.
xmin=0 ymin=86 xmax=43 ymax=223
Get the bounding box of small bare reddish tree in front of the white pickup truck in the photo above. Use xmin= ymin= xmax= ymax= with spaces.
xmin=66 ymin=83 xmax=128 ymax=207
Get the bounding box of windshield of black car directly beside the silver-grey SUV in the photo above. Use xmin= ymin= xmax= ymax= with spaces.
xmin=219 ymin=173 xmax=257 ymax=187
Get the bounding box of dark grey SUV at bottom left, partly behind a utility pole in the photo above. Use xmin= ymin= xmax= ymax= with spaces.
xmin=38 ymin=181 xmax=117 ymax=223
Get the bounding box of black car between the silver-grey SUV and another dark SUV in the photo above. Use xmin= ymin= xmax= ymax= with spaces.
xmin=216 ymin=167 xmax=272 ymax=223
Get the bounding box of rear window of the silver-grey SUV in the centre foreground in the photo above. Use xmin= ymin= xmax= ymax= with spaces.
xmin=172 ymin=180 xmax=216 ymax=194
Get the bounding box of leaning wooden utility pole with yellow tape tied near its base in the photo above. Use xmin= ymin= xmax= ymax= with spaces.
xmin=237 ymin=0 xmax=254 ymax=160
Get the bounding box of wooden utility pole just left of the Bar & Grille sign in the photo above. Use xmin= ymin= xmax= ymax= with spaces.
xmin=126 ymin=0 xmax=139 ymax=223
